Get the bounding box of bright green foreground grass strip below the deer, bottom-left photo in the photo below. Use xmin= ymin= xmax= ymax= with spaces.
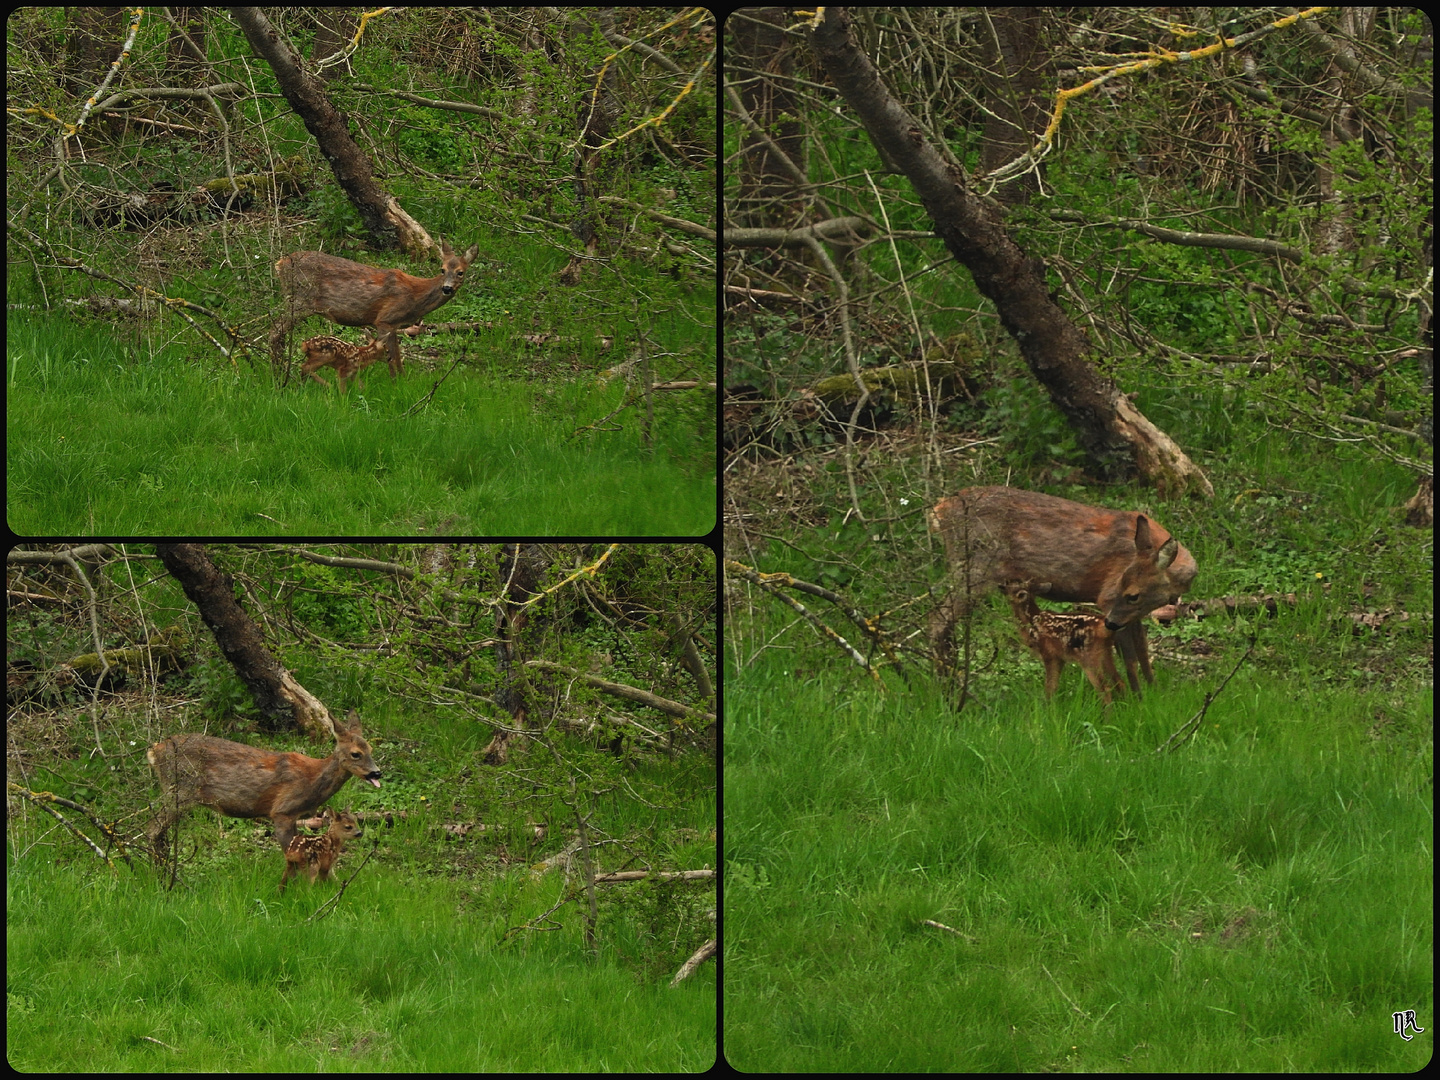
xmin=6 ymin=840 xmax=716 ymax=1073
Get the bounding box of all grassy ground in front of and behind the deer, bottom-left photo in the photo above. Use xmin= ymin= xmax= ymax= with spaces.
xmin=6 ymin=703 xmax=717 ymax=1073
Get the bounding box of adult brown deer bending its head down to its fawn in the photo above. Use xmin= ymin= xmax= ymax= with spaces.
xmin=929 ymin=487 xmax=1198 ymax=677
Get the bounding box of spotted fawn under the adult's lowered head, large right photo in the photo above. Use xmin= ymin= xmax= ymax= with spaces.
xmin=999 ymin=580 xmax=1155 ymax=704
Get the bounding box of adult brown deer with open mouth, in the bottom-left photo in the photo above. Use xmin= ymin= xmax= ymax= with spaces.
xmin=145 ymin=708 xmax=382 ymax=857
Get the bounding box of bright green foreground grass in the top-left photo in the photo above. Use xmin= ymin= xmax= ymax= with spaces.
xmin=7 ymin=312 xmax=716 ymax=536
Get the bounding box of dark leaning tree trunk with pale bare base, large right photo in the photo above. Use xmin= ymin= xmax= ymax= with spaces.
xmin=811 ymin=7 xmax=1214 ymax=497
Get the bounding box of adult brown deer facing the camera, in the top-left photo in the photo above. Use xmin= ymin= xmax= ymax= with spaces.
xmin=269 ymin=239 xmax=480 ymax=379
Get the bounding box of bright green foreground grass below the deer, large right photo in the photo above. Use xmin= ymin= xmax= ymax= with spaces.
xmin=724 ymin=648 xmax=1433 ymax=1071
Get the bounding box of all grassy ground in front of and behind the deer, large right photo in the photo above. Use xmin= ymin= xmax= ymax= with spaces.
xmin=724 ymin=417 xmax=1434 ymax=1073
